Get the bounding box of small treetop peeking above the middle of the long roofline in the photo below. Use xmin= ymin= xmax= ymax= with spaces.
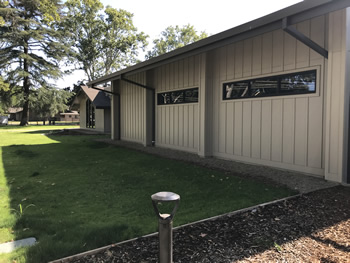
xmin=146 ymin=24 xmax=208 ymax=59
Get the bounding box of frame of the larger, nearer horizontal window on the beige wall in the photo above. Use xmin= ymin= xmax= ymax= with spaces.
xmin=221 ymin=67 xmax=320 ymax=101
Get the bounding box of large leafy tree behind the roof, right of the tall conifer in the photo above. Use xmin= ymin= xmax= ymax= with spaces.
xmin=61 ymin=0 xmax=147 ymax=81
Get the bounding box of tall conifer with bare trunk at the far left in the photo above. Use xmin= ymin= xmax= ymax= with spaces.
xmin=0 ymin=0 xmax=69 ymax=125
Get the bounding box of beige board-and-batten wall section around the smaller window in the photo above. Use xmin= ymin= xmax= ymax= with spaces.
xmin=152 ymin=56 xmax=199 ymax=152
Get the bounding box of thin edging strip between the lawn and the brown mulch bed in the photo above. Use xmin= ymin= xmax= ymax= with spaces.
xmin=48 ymin=193 xmax=306 ymax=263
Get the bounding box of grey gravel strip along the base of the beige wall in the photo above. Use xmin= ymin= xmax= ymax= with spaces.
xmin=98 ymin=139 xmax=338 ymax=193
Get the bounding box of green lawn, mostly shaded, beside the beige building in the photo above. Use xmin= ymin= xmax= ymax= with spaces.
xmin=0 ymin=126 xmax=294 ymax=263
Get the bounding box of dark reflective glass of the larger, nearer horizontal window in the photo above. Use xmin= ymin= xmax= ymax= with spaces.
xmin=223 ymin=70 xmax=316 ymax=100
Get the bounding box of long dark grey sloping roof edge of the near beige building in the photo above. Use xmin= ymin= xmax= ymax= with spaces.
xmin=87 ymin=0 xmax=350 ymax=86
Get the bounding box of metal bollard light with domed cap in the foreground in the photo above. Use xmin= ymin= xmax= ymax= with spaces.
xmin=151 ymin=192 xmax=180 ymax=263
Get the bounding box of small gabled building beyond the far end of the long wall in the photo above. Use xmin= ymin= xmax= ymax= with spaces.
xmin=71 ymin=86 xmax=111 ymax=133
